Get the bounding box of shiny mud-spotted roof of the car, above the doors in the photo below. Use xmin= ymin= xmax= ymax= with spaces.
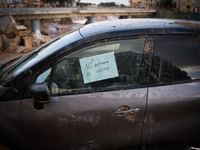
xmin=80 ymin=18 xmax=200 ymax=37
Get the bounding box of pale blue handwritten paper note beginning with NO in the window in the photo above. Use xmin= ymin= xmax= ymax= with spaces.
xmin=79 ymin=52 xmax=119 ymax=83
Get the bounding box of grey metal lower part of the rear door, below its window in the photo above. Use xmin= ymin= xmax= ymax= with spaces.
xmin=143 ymin=82 xmax=200 ymax=146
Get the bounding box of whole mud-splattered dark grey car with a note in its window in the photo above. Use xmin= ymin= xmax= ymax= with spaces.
xmin=0 ymin=19 xmax=200 ymax=150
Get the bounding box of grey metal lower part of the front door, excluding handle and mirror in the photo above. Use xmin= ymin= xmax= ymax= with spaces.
xmin=20 ymin=88 xmax=147 ymax=150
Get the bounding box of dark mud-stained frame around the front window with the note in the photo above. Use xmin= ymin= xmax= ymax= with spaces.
xmin=26 ymin=35 xmax=155 ymax=97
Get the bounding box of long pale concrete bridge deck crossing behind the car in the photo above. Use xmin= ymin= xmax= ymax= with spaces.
xmin=0 ymin=7 xmax=157 ymax=20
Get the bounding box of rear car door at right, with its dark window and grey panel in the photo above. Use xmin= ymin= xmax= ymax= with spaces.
xmin=143 ymin=36 xmax=200 ymax=149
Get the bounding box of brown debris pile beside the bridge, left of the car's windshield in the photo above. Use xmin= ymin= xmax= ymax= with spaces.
xmin=0 ymin=16 xmax=52 ymax=53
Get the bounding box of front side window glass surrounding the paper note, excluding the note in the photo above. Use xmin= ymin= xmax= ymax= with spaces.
xmin=53 ymin=39 xmax=145 ymax=94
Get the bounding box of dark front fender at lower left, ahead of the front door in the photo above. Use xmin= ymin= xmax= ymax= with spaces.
xmin=0 ymin=100 xmax=26 ymax=149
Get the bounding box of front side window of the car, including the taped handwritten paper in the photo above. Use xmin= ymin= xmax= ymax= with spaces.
xmin=52 ymin=39 xmax=145 ymax=94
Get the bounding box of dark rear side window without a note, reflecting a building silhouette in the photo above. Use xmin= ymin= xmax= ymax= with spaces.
xmin=152 ymin=37 xmax=200 ymax=83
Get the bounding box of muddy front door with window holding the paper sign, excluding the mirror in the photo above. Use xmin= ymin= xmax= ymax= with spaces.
xmin=20 ymin=37 xmax=153 ymax=150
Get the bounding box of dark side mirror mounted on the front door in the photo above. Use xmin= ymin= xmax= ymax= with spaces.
xmin=29 ymin=82 xmax=50 ymax=109
